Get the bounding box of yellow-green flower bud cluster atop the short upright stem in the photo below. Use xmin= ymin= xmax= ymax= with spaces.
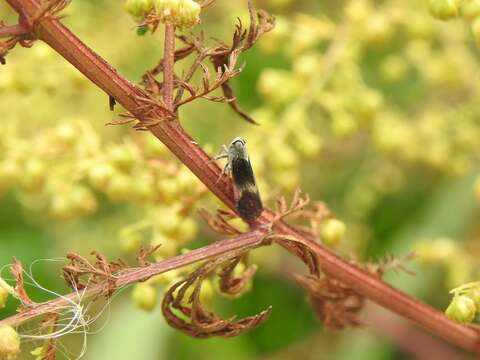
xmin=155 ymin=0 xmax=201 ymax=27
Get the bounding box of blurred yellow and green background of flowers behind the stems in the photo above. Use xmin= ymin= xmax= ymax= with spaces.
xmin=0 ymin=0 xmax=480 ymax=360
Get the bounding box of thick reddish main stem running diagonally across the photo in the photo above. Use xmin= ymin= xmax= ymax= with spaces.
xmin=7 ymin=0 xmax=480 ymax=353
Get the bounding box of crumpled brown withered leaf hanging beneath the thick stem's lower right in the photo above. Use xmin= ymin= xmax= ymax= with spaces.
xmin=295 ymin=275 xmax=364 ymax=330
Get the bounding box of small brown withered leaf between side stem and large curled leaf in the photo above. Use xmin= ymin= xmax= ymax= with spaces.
xmin=218 ymin=255 xmax=257 ymax=296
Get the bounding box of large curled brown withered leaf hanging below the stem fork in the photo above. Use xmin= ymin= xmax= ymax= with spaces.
xmin=162 ymin=261 xmax=271 ymax=338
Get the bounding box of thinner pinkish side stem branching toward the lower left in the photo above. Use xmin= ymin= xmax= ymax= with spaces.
xmin=0 ymin=230 xmax=266 ymax=326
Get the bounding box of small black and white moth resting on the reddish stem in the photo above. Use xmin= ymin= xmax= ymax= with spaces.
xmin=214 ymin=137 xmax=263 ymax=221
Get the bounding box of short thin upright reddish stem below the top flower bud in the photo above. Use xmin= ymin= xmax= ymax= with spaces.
xmin=162 ymin=22 xmax=175 ymax=111
